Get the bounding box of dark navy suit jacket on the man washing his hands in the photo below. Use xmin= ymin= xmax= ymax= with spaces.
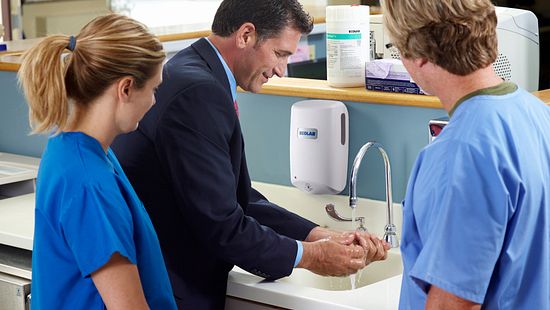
xmin=113 ymin=39 xmax=315 ymax=310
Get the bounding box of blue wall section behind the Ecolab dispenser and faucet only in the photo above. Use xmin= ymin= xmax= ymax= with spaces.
xmin=237 ymin=93 xmax=447 ymax=202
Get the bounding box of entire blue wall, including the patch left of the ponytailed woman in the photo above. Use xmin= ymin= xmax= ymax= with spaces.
xmin=0 ymin=71 xmax=446 ymax=201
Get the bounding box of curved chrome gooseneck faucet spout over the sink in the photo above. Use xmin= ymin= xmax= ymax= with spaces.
xmin=349 ymin=141 xmax=399 ymax=248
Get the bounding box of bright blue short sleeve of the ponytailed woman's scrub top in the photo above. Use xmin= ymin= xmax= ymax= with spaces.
xmin=61 ymin=185 xmax=136 ymax=277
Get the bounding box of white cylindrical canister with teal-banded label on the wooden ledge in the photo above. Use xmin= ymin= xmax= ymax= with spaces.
xmin=326 ymin=5 xmax=370 ymax=87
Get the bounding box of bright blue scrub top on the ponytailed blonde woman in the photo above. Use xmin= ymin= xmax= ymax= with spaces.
xmin=31 ymin=132 xmax=176 ymax=310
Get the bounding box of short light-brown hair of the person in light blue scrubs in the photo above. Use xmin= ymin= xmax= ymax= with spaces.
xmin=382 ymin=0 xmax=498 ymax=76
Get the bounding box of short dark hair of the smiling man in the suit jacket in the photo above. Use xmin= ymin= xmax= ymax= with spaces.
xmin=212 ymin=0 xmax=313 ymax=41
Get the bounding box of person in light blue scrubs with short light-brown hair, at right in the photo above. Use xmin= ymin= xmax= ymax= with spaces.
xmin=383 ymin=0 xmax=550 ymax=310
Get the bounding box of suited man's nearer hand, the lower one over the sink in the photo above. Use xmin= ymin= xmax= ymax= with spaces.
xmin=297 ymin=239 xmax=366 ymax=276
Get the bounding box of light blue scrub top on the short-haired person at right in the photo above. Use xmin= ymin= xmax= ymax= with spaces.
xmin=400 ymin=89 xmax=550 ymax=309
